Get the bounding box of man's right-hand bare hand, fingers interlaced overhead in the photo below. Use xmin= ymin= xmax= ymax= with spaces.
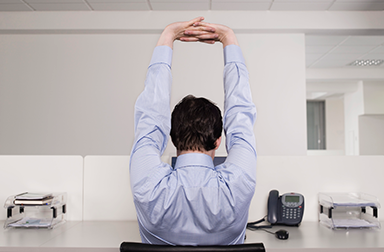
xmin=184 ymin=21 xmax=239 ymax=47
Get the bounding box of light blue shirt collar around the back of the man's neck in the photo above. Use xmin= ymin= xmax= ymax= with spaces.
xmin=175 ymin=153 xmax=214 ymax=170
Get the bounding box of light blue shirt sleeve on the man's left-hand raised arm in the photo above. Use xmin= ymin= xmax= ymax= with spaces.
xmin=130 ymin=46 xmax=173 ymax=192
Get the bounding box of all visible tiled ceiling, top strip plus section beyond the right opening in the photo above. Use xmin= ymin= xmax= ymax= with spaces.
xmin=0 ymin=0 xmax=384 ymax=69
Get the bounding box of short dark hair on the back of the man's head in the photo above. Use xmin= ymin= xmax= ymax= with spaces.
xmin=171 ymin=95 xmax=223 ymax=151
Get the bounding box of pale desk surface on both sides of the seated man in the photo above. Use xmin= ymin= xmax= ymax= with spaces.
xmin=0 ymin=221 xmax=384 ymax=252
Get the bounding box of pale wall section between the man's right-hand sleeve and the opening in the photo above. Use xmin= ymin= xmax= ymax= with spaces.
xmin=239 ymin=34 xmax=307 ymax=155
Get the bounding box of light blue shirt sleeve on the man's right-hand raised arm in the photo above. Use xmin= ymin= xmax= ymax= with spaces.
xmin=221 ymin=45 xmax=257 ymax=189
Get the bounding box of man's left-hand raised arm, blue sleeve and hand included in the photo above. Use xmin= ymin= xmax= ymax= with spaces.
xmin=130 ymin=17 xmax=218 ymax=191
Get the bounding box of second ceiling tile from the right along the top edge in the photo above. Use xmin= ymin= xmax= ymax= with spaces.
xmin=271 ymin=1 xmax=331 ymax=11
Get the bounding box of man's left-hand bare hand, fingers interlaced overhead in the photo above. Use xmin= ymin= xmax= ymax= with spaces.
xmin=157 ymin=17 xmax=218 ymax=48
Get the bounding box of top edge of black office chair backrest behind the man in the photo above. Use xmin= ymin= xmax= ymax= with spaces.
xmin=120 ymin=242 xmax=265 ymax=252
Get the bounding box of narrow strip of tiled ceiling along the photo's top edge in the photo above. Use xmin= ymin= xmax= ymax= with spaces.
xmin=0 ymin=0 xmax=384 ymax=11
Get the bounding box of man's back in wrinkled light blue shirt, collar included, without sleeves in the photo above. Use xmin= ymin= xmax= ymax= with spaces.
xmin=135 ymin=153 xmax=254 ymax=245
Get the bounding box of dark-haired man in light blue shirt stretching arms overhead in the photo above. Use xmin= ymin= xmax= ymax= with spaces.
xmin=130 ymin=18 xmax=256 ymax=245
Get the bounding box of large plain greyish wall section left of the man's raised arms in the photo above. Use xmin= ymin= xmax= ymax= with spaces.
xmin=0 ymin=34 xmax=158 ymax=155
